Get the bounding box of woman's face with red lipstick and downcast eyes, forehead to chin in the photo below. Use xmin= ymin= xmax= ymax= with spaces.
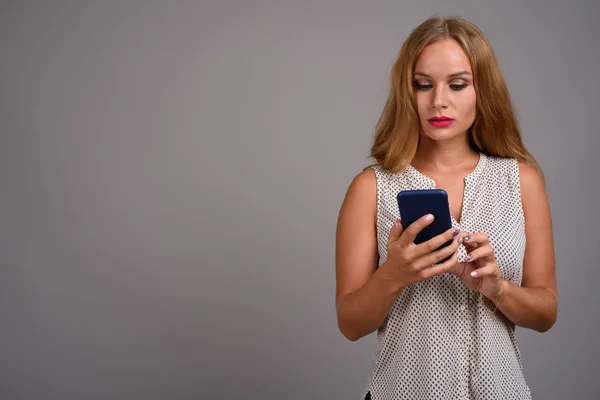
xmin=413 ymin=39 xmax=476 ymax=141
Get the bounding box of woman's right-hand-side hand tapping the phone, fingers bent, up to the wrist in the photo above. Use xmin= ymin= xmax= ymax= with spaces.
xmin=451 ymin=232 xmax=504 ymax=301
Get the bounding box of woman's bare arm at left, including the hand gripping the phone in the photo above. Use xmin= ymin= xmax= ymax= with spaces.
xmin=336 ymin=170 xmax=459 ymax=341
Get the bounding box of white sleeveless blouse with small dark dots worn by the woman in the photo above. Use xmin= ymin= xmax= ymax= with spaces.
xmin=362 ymin=153 xmax=531 ymax=400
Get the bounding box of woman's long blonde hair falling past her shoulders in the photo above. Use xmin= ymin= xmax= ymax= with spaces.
xmin=371 ymin=17 xmax=544 ymax=178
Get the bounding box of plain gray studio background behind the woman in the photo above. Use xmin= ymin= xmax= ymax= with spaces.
xmin=0 ymin=0 xmax=600 ymax=400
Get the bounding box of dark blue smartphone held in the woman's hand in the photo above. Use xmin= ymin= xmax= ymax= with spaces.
xmin=397 ymin=189 xmax=452 ymax=263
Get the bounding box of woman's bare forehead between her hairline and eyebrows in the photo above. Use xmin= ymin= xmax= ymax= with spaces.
xmin=415 ymin=39 xmax=472 ymax=76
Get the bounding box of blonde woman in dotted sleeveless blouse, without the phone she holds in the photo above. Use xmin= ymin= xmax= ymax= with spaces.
xmin=336 ymin=18 xmax=558 ymax=400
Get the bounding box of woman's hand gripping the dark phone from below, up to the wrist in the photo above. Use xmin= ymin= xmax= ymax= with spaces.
xmin=382 ymin=215 xmax=460 ymax=287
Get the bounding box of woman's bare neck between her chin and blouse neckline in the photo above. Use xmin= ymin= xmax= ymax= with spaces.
xmin=412 ymin=133 xmax=479 ymax=173
